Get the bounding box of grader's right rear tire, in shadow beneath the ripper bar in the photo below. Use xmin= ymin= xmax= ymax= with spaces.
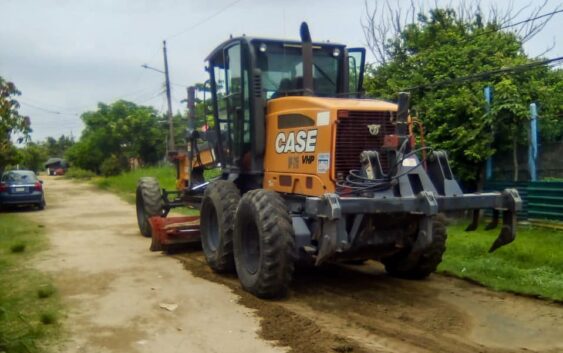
xmin=381 ymin=216 xmax=447 ymax=279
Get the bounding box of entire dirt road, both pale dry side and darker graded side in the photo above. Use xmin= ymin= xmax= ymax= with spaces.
xmin=24 ymin=179 xmax=563 ymax=353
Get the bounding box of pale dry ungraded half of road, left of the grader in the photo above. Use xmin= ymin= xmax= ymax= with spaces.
xmin=28 ymin=178 xmax=285 ymax=353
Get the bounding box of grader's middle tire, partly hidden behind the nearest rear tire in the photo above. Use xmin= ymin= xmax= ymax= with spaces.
xmin=200 ymin=180 xmax=240 ymax=272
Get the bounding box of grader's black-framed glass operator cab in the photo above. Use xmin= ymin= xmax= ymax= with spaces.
xmin=206 ymin=34 xmax=365 ymax=175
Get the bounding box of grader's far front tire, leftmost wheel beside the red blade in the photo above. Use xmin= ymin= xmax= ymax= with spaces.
xmin=135 ymin=177 xmax=163 ymax=238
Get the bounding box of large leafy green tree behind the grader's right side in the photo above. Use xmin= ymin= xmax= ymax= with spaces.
xmin=365 ymin=1 xmax=563 ymax=186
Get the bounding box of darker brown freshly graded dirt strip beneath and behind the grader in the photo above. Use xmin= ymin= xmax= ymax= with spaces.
xmin=174 ymin=249 xmax=563 ymax=353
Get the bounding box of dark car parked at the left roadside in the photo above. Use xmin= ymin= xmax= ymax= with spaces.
xmin=0 ymin=170 xmax=45 ymax=210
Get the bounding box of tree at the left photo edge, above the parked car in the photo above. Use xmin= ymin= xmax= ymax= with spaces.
xmin=0 ymin=77 xmax=31 ymax=170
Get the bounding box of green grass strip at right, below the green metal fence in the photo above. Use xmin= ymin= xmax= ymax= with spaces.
xmin=438 ymin=223 xmax=563 ymax=301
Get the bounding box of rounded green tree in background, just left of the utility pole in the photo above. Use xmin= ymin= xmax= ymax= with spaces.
xmin=66 ymin=100 xmax=165 ymax=172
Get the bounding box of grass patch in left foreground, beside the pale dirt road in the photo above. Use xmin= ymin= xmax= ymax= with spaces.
xmin=0 ymin=214 xmax=62 ymax=353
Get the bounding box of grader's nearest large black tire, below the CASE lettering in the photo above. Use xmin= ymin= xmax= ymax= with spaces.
xmin=234 ymin=189 xmax=297 ymax=299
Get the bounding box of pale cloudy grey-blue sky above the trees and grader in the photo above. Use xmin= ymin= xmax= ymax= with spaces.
xmin=0 ymin=0 xmax=563 ymax=141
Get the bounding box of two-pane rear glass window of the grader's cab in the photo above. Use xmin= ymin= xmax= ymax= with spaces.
xmin=256 ymin=42 xmax=343 ymax=99
